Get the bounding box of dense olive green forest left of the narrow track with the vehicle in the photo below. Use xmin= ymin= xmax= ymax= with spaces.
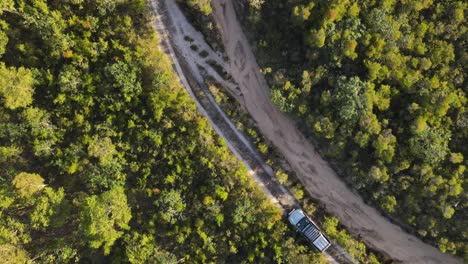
xmin=0 ymin=0 xmax=322 ymax=264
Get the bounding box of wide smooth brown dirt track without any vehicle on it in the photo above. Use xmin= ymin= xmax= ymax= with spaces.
xmin=209 ymin=0 xmax=462 ymax=263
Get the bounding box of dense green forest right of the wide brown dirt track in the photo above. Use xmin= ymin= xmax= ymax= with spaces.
xmin=243 ymin=0 xmax=468 ymax=258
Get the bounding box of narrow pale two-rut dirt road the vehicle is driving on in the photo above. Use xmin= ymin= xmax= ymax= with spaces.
xmin=150 ymin=0 xmax=355 ymax=264
